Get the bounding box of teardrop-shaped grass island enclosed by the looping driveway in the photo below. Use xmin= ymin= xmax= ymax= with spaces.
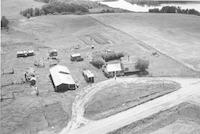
xmin=85 ymin=80 xmax=180 ymax=120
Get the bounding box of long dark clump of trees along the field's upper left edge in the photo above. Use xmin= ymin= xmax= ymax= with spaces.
xmin=20 ymin=2 xmax=89 ymax=18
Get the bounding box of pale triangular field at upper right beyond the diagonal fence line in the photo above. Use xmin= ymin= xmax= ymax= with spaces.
xmin=93 ymin=13 xmax=200 ymax=71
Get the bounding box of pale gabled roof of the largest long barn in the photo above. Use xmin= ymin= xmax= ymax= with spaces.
xmin=49 ymin=65 xmax=75 ymax=86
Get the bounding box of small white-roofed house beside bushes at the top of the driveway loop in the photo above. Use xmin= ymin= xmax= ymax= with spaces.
xmin=103 ymin=63 xmax=124 ymax=78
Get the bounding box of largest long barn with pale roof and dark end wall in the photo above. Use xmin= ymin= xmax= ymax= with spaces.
xmin=49 ymin=65 xmax=76 ymax=91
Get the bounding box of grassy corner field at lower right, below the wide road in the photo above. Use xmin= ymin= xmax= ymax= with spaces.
xmin=110 ymin=102 xmax=200 ymax=134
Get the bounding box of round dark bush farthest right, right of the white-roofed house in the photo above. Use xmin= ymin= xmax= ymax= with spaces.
xmin=135 ymin=58 xmax=149 ymax=72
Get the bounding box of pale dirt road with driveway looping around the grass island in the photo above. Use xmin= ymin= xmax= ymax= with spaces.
xmin=60 ymin=78 xmax=200 ymax=134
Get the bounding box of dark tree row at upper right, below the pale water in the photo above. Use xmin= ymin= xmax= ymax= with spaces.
xmin=149 ymin=6 xmax=200 ymax=15
